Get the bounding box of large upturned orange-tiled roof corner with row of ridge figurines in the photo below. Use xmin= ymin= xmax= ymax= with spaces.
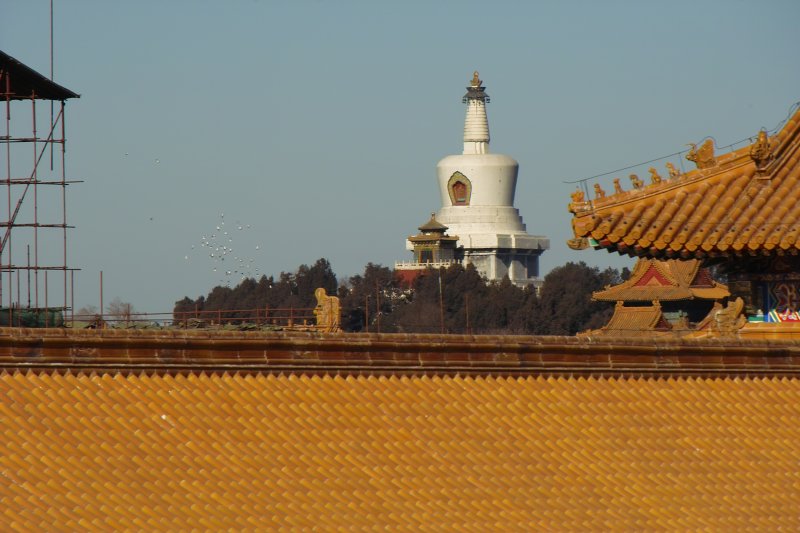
xmin=570 ymin=104 xmax=800 ymax=258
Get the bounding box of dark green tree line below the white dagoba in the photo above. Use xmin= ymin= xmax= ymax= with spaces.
xmin=173 ymin=259 xmax=629 ymax=335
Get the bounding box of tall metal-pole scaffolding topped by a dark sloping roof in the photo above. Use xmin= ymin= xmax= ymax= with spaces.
xmin=0 ymin=51 xmax=79 ymax=327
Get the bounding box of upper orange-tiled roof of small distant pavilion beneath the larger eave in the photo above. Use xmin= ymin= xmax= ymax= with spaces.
xmin=592 ymin=258 xmax=730 ymax=302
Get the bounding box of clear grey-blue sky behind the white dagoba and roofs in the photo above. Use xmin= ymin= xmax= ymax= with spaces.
xmin=0 ymin=0 xmax=800 ymax=312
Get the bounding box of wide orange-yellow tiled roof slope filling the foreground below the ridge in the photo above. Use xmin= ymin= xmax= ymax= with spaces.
xmin=0 ymin=372 xmax=800 ymax=531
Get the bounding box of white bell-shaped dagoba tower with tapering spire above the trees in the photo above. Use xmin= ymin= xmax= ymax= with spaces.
xmin=428 ymin=71 xmax=550 ymax=287
